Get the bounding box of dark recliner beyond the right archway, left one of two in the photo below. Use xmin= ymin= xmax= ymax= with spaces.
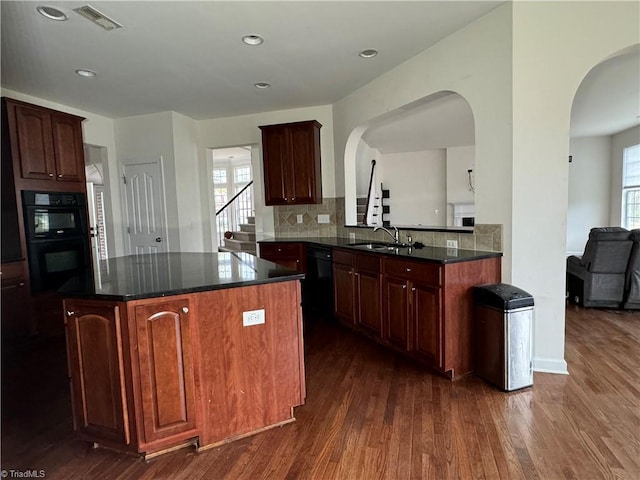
xmin=567 ymin=227 xmax=633 ymax=308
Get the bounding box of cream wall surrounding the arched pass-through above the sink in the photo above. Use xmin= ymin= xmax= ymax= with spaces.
xmin=334 ymin=4 xmax=512 ymax=268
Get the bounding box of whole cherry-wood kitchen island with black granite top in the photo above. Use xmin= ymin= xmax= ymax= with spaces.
xmin=59 ymin=253 xmax=305 ymax=458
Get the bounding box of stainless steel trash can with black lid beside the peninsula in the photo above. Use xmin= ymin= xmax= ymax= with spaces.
xmin=473 ymin=283 xmax=533 ymax=391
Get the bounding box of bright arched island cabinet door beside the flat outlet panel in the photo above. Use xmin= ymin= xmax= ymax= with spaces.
xmin=135 ymin=299 xmax=196 ymax=443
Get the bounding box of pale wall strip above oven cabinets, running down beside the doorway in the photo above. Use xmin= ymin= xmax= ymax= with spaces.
xmin=0 ymin=88 xmax=124 ymax=255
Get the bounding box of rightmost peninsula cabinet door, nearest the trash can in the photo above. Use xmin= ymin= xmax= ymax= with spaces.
xmin=409 ymin=283 xmax=444 ymax=368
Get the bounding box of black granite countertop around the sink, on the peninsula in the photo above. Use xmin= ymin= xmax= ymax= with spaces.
xmin=258 ymin=237 xmax=502 ymax=263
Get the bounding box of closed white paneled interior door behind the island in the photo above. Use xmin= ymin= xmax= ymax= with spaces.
xmin=124 ymin=159 xmax=168 ymax=254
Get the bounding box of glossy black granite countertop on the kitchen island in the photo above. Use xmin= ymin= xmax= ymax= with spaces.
xmin=58 ymin=253 xmax=304 ymax=301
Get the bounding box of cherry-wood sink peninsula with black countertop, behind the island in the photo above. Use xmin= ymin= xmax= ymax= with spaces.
xmin=259 ymin=237 xmax=502 ymax=379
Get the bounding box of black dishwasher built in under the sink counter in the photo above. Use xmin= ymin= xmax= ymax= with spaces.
xmin=302 ymin=244 xmax=333 ymax=319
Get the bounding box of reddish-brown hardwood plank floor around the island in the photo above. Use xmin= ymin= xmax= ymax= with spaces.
xmin=2 ymin=306 xmax=640 ymax=480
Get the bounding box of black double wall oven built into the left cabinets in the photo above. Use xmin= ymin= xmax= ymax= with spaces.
xmin=22 ymin=190 xmax=90 ymax=292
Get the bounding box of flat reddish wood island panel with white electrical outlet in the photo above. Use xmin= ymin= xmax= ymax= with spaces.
xmin=197 ymin=282 xmax=306 ymax=447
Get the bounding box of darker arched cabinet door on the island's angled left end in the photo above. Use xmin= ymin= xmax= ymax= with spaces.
xmin=64 ymin=300 xmax=131 ymax=445
